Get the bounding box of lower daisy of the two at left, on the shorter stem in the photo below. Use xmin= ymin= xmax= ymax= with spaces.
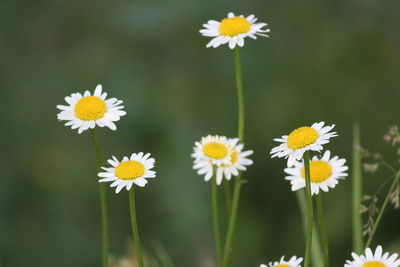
xmin=98 ymin=152 xmax=156 ymax=193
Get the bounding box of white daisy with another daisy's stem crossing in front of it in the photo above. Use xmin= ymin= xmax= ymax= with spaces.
xmin=285 ymin=150 xmax=348 ymax=195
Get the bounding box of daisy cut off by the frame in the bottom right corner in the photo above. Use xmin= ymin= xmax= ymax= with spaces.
xmin=344 ymin=246 xmax=400 ymax=267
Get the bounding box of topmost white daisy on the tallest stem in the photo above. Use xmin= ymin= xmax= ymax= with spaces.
xmin=200 ymin=12 xmax=270 ymax=49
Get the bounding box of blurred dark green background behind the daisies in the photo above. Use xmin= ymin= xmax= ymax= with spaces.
xmin=0 ymin=0 xmax=400 ymax=267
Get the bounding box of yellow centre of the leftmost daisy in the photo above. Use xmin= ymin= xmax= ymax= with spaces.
xmin=75 ymin=96 xmax=107 ymax=121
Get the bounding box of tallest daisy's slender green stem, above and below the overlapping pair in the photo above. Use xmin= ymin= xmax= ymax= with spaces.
xmin=222 ymin=47 xmax=245 ymax=267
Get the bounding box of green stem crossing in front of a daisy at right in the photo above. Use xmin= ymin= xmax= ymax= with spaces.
xmin=303 ymin=151 xmax=314 ymax=267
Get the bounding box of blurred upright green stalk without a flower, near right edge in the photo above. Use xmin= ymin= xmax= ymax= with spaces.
xmin=352 ymin=123 xmax=363 ymax=254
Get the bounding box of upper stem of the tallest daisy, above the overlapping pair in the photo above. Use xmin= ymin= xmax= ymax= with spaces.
xmin=235 ymin=46 xmax=245 ymax=142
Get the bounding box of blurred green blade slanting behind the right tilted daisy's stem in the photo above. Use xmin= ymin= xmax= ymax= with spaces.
xmin=296 ymin=190 xmax=323 ymax=266
